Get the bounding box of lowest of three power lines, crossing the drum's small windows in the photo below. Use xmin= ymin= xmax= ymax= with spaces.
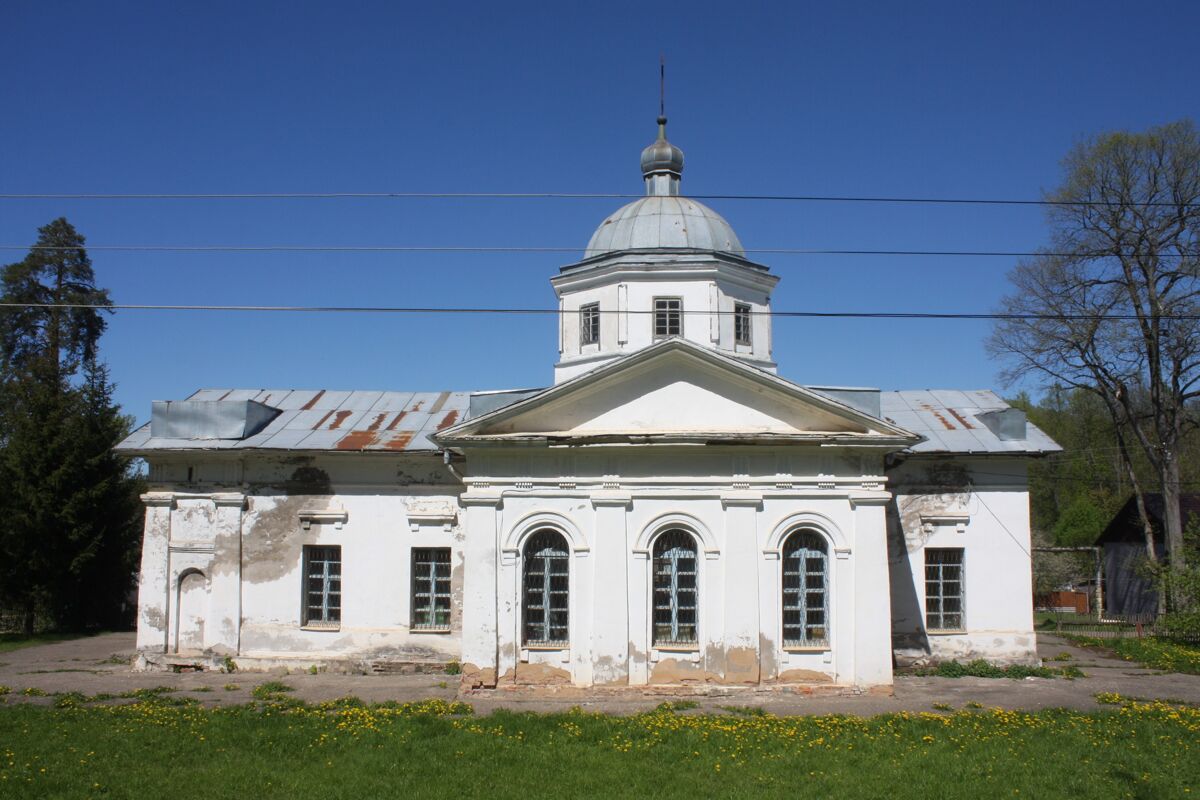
xmin=7 ymin=302 xmax=1200 ymax=321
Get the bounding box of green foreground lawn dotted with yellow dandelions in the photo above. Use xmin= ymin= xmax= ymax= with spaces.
xmin=0 ymin=694 xmax=1200 ymax=800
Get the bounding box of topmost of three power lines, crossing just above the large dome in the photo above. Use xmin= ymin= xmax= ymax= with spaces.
xmin=0 ymin=192 xmax=1177 ymax=207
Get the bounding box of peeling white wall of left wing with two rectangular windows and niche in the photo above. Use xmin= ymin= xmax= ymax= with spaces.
xmin=138 ymin=455 xmax=463 ymax=666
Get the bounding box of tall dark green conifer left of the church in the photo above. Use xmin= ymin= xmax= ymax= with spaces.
xmin=0 ymin=218 xmax=140 ymax=632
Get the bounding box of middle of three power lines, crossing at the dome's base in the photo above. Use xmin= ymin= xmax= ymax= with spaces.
xmin=0 ymin=245 xmax=1200 ymax=258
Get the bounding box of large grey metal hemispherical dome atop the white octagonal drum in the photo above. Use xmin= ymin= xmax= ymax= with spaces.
xmin=584 ymin=194 xmax=745 ymax=258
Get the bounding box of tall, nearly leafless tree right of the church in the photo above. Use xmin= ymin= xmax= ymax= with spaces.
xmin=989 ymin=120 xmax=1200 ymax=597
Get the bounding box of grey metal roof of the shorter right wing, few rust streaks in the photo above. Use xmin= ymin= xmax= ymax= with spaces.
xmin=880 ymin=389 xmax=1062 ymax=455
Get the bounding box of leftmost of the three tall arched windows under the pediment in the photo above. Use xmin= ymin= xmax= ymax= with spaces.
xmin=522 ymin=530 xmax=571 ymax=645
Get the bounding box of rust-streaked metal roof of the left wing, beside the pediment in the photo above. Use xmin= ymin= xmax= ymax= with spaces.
xmin=118 ymin=389 xmax=470 ymax=452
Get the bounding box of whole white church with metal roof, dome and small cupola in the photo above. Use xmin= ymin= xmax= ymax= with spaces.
xmin=119 ymin=118 xmax=1058 ymax=690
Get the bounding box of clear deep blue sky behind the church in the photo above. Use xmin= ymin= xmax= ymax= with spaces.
xmin=0 ymin=0 xmax=1200 ymax=420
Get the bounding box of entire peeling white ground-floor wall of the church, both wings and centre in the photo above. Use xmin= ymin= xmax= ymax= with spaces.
xmin=138 ymin=446 xmax=1036 ymax=686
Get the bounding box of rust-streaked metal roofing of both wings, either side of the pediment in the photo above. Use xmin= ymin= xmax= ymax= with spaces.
xmin=118 ymin=389 xmax=1062 ymax=455
